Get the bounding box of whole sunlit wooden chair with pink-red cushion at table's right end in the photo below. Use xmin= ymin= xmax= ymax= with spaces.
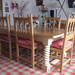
xmin=51 ymin=15 xmax=75 ymax=72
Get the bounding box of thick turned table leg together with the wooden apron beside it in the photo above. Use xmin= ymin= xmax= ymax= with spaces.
xmin=35 ymin=37 xmax=53 ymax=72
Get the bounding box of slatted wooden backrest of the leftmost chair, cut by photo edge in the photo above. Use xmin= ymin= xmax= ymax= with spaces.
xmin=0 ymin=15 xmax=10 ymax=37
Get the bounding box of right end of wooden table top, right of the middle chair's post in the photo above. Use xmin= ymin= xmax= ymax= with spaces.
xmin=34 ymin=27 xmax=64 ymax=37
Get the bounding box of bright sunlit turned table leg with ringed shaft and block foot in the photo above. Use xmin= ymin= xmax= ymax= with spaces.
xmin=42 ymin=39 xmax=53 ymax=72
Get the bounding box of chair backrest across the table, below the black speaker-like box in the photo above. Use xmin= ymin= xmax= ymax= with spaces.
xmin=44 ymin=16 xmax=61 ymax=29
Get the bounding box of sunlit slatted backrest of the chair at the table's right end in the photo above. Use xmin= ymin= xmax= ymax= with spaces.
xmin=63 ymin=15 xmax=75 ymax=49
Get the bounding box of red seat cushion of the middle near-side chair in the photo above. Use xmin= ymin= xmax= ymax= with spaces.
xmin=17 ymin=40 xmax=42 ymax=46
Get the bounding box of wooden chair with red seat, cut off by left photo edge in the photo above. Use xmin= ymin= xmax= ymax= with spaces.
xmin=0 ymin=15 xmax=15 ymax=59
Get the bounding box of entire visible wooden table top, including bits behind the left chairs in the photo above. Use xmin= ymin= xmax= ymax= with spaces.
xmin=0 ymin=26 xmax=64 ymax=38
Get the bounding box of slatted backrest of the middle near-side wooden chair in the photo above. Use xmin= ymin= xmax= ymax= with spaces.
xmin=13 ymin=14 xmax=34 ymax=46
